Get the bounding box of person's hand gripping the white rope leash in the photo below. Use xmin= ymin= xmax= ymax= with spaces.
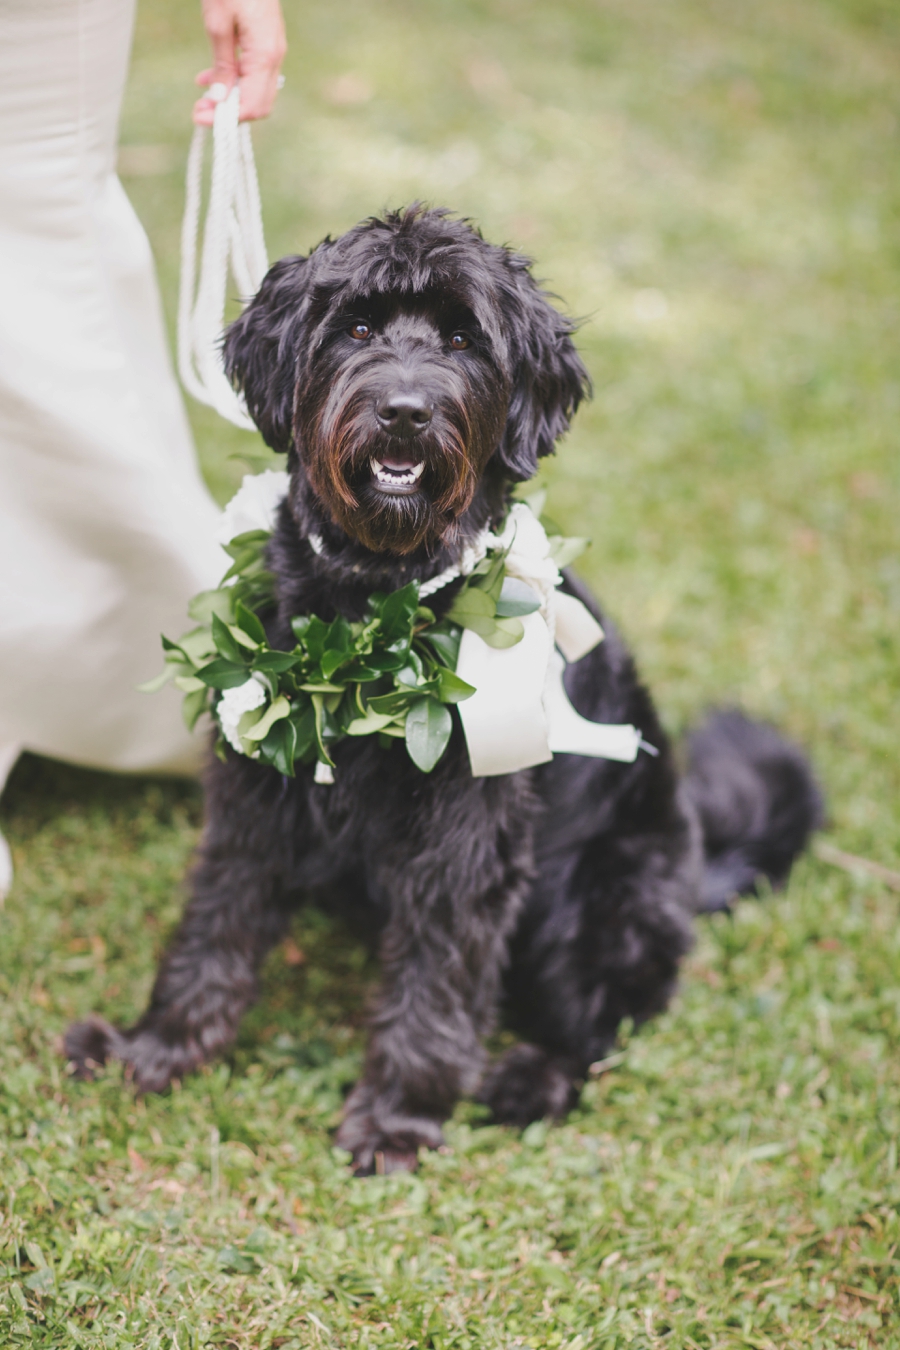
xmin=194 ymin=0 xmax=287 ymax=127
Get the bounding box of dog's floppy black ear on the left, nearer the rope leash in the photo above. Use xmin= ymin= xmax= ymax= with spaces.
xmin=224 ymin=258 xmax=313 ymax=451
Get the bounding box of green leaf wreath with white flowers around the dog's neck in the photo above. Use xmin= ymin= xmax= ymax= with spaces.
xmin=140 ymin=491 xmax=582 ymax=778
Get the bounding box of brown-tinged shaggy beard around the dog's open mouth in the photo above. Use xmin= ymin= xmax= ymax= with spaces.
xmin=297 ymin=396 xmax=493 ymax=554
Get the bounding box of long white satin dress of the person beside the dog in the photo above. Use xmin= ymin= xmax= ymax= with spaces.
xmin=0 ymin=0 xmax=225 ymax=787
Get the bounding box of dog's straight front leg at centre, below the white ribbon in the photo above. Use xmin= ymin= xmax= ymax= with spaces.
xmin=337 ymin=774 xmax=533 ymax=1176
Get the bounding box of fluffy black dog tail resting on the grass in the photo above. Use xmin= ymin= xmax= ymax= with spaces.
xmin=685 ymin=709 xmax=823 ymax=911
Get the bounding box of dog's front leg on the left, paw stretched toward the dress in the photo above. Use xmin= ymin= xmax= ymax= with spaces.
xmin=65 ymin=759 xmax=298 ymax=1092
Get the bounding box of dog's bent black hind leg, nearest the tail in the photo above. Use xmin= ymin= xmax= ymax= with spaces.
xmin=480 ymin=788 xmax=700 ymax=1127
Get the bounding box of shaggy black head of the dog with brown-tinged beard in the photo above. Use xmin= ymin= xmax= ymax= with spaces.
xmin=225 ymin=208 xmax=587 ymax=554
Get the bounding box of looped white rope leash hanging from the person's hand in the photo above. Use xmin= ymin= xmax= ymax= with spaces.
xmin=178 ymin=85 xmax=269 ymax=431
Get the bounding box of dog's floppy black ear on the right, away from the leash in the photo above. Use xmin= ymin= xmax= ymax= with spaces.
xmin=497 ymin=255 xmax=591 ymax=481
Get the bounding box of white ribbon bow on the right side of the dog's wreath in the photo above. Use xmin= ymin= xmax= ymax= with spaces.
xmin=456 ymin=502 xmax=642 ymax=778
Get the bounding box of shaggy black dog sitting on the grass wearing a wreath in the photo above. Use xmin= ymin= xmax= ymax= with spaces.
xmin=66 ymin=208 xmax=819 ymax=1173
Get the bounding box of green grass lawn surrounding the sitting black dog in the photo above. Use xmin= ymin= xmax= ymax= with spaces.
xmin=0 ymin=0 xmax=900 ymax=1350
